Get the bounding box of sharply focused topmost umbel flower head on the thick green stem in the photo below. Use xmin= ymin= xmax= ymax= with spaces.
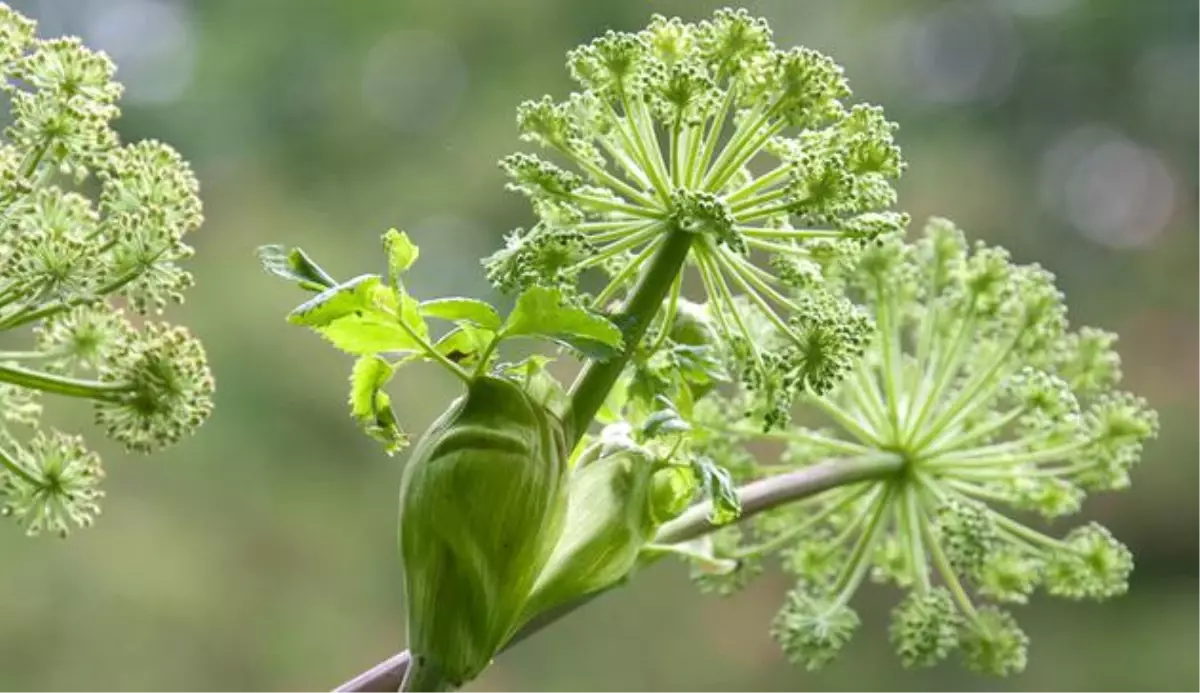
xmin=485 ymin=10 xmax=907 ymax=428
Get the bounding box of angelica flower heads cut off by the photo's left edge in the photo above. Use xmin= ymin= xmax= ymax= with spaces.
xmin=0 ymin=4 xmax=212 ymax=535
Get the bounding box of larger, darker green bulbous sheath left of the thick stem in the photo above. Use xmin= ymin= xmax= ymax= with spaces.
xmin=400 ymin=376 xmax=569 ymax=685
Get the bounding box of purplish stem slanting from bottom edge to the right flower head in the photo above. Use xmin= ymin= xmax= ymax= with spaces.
xmin=332 ymin=457 xmax=904 ymax=693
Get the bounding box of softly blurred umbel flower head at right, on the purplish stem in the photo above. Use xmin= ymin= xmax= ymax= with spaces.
xmin=701 ymin=219 xmax=1158 ymax=675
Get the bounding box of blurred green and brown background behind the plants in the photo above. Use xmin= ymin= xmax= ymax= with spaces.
xmin=0 ymin=0 xmax=1200 ymax=693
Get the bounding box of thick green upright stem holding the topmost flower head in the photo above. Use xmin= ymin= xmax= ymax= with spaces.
xmin=563 ymin=229 xmax=695 ymax=445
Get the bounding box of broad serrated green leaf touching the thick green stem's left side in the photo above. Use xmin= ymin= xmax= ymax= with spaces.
xmin=500 ymin=287 xmax=623 ymax=360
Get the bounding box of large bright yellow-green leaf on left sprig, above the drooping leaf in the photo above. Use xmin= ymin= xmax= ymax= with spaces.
xmin=288 ymin=275 xmax=428 ymax=356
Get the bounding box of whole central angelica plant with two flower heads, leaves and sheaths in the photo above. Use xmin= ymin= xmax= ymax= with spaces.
xmin=259 ymin=10 xmax=1157 ymax=693
